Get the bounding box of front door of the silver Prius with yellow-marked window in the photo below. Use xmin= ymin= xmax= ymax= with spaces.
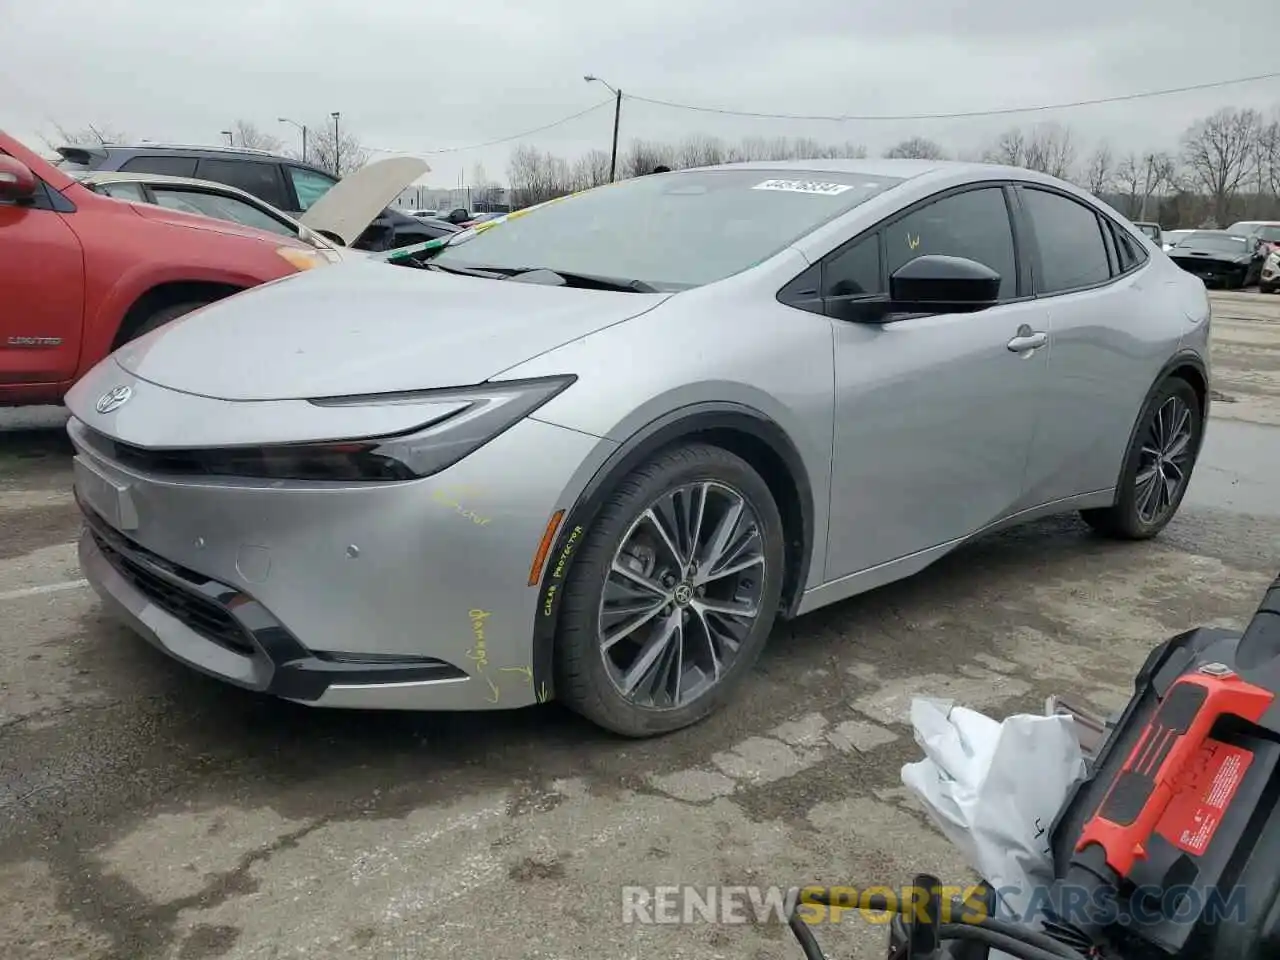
xmin=822 ymin=184 xmax=1048 ymax=580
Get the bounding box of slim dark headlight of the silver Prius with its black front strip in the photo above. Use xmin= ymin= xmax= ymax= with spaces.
xmin=97 ymin=376 xmax=577 ymax=483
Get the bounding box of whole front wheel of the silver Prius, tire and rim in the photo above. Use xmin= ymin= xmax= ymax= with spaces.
xmin=556 ymin=444 xmax=783 ymax=737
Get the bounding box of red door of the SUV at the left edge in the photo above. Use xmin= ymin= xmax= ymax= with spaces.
xmin=0 ymin=183 xmax=84 ymax=384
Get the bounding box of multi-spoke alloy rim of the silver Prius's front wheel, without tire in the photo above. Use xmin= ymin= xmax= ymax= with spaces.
xmin=598 ymin=481 xmax=767 ymax=709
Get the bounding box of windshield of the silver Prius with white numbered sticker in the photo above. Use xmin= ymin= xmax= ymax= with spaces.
xmin=431 ymin=169 xmax=901 ymax=291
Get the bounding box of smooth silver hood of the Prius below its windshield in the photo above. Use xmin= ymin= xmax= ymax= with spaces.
xmin=114 ymin=253 xmax=672 ymax=401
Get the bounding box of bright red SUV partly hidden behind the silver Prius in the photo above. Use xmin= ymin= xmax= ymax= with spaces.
xmin=0 ymin=132 xmax=330 ymax=406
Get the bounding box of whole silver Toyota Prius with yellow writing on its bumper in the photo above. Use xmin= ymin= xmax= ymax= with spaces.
xmin=68 ymin=160 xmax=1210 ymax=737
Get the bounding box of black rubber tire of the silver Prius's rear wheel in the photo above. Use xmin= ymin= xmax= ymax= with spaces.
xmin=1080 ymin=376 xmax=1204 ymax=540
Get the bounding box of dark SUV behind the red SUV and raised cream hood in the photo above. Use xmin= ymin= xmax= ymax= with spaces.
xmin=58 ymin=143 xmax=457 ymax=251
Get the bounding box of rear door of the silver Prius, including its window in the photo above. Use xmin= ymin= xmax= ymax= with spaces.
xmin=1016 ymin=184 xmax=1183 ymax=503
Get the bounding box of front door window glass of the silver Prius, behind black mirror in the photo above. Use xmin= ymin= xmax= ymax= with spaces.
xmin=884 ymin=187 xmax=1013 ymax=300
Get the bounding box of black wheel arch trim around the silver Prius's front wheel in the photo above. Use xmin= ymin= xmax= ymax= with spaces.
xmin=532 ymin=403 xmax=814 ymax=700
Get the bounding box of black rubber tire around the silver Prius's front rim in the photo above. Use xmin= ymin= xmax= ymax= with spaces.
xmin=556 ymin=444 xmax=786 ymax=739
